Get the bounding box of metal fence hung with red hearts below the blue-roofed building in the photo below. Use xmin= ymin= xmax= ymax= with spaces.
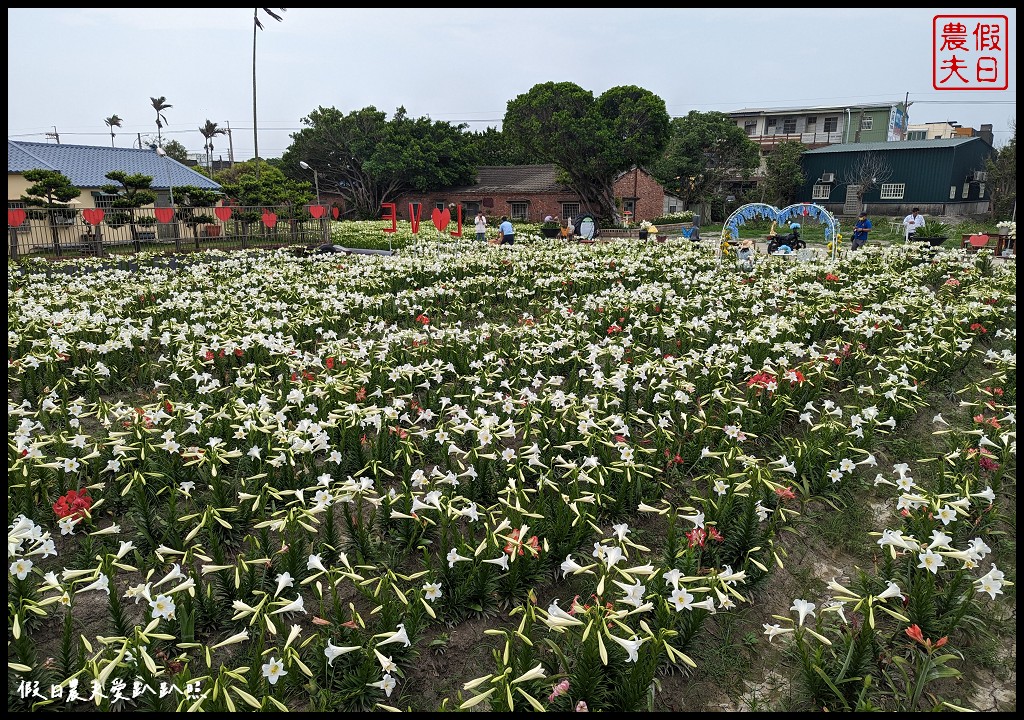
xmin=7 ymin=206 xmax=331 ymax=260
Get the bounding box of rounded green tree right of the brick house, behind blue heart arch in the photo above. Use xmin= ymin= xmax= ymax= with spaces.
xmin=655 ymin=111 xmax=759 ymax=217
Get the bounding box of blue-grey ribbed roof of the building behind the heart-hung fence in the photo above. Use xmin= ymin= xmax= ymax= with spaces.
xmin=7 ymin=139 xmax=220 ymax=190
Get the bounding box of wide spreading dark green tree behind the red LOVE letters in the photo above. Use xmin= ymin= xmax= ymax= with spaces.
xmin=282 ymin=107 xmax=476 ymax=219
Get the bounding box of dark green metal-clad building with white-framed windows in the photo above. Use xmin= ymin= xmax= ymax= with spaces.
xmin=798 ymin=137 xmax=995 ymax=217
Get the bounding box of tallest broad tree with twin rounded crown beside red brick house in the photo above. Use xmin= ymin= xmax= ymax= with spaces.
xmin=502 ymin=82 xmax=670 ymax=221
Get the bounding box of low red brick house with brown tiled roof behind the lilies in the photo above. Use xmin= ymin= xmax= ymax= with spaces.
xmin=387 ymin=165 xmax=666 ymax=225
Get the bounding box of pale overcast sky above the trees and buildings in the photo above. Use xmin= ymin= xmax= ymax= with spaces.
xmin=7 ymin=7 xmax=1017 ymax=161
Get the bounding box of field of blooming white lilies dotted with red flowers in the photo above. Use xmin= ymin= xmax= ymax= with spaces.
xmin=8 ymin=233 xmax=1016 ymax=711
